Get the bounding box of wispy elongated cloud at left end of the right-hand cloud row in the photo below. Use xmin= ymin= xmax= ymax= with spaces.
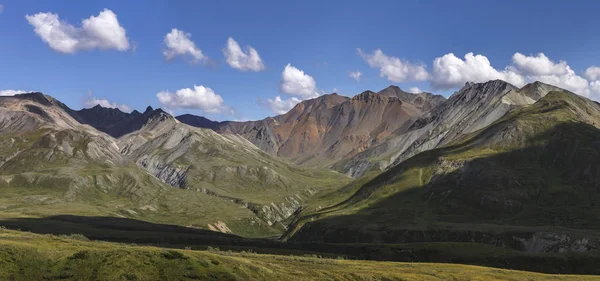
xmin=357 ymin=49 xmax=429 ymax=82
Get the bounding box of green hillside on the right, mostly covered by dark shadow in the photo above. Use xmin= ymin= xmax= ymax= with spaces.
xmin=288 ymin=91 xmax=600 ymax=252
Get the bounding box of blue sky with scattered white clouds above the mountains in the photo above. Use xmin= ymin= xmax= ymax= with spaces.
xmin=0 ymin=0 xmax=600 ymax=120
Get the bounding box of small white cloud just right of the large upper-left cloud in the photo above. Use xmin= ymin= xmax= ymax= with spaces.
xmin=163 ymin=28 xmax=208 ymax=62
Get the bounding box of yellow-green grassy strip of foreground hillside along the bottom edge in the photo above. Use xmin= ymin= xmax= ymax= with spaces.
xmin=0 ymin=229 xmax=600 ymax=281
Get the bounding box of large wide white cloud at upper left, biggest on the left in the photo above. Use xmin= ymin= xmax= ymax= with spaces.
xmin=25 ymin=9 xmax=129 ymax=54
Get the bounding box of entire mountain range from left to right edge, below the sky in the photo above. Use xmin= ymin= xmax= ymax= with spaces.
xmin=0 ymin=80 xmax=600 ymax=252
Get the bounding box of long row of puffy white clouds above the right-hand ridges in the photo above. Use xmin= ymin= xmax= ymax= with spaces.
xmin=358 ymin=49 xmax=600 ymax=98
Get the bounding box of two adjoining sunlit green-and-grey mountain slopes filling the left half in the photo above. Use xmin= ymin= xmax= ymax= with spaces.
xmin=0 ymin=93 xmax=348 ymax=236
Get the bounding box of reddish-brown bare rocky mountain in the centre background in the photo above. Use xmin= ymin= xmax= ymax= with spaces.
xmin=178 ymin=86 xmax=445 ymax=166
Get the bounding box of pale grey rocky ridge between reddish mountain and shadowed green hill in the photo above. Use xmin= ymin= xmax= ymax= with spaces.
xmin=333 ymin=80 xmax=562 ymax=177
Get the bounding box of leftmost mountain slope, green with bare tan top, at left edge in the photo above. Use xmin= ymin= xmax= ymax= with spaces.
xmin=0 ymin=93 xmax=272 ymax=235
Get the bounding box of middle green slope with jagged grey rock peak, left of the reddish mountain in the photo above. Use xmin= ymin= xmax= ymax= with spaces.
xmin=118 ymin=110 xmax=348 ymax=227
